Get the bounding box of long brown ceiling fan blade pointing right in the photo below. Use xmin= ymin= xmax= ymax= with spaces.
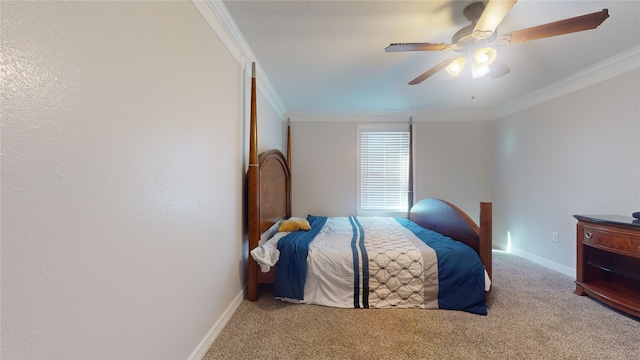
xmin=496 ymin=9 xmax=609 ymax=45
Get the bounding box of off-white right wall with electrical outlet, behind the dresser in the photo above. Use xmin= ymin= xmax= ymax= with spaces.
xmin=493 ymin=68 xmax=640 ymax=276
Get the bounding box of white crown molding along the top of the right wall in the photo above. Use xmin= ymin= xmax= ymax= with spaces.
xmin=495 ymin=46 xmax=640 ymax=119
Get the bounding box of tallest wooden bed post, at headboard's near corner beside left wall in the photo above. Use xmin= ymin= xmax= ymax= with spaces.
xmin=247 ymin=62 xmax=260 ymax=301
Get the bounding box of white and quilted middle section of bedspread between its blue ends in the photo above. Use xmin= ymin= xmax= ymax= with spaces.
xmin=304 ymin=217 xmax=438 ymax=308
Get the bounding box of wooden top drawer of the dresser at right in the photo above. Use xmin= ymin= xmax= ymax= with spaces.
xmin=582 ymin=225 xmax=640 ymax=257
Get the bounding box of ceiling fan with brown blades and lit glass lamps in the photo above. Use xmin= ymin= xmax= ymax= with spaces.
xmin=384 ymin=0 xmax=609 ymax=85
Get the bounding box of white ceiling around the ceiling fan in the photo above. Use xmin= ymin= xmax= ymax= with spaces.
xmin=224 ymin=0 xmax=640 ymax=113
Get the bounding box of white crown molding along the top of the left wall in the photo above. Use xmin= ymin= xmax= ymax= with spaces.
xmin=191 ymin=0 xmax=287 ymax=117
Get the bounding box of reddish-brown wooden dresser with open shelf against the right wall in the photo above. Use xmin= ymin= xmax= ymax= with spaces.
xmin=574 ymin=215 xmax=640 ymax=317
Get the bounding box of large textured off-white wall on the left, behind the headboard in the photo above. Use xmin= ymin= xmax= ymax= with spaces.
xmin=0 ymin=1 xmax=282 ymax=359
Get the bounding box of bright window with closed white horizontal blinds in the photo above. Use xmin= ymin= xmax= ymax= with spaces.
xmin=357 ymin=125 xmax=410 ymax=216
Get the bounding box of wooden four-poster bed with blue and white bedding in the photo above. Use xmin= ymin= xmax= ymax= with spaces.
xmin=247 ymin=63 xmax=492 ymax=315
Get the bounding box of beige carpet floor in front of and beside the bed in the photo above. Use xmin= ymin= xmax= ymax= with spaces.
xmin=204 ymin=251 xmax=640 ymax=360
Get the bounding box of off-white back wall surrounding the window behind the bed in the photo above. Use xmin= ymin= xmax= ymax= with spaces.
xmin=291 ymin=114 xmax=493 ymax=221
